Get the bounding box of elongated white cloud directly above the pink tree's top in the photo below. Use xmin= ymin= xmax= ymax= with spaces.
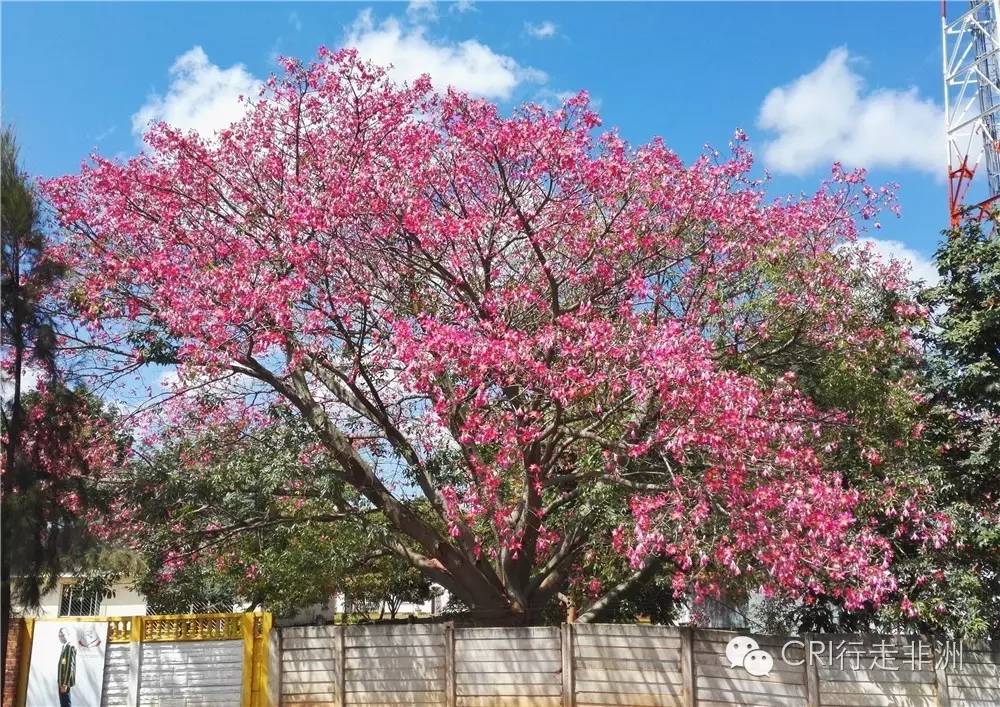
xmin=344 ymin=10 xmax=546 ymax=99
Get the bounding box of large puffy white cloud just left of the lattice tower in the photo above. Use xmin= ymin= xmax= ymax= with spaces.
xmin=758 ymin=47 xmax=945 ymax=175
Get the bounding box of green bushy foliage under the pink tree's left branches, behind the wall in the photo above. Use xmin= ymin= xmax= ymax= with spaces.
xmin=125 ymin=417 xmax=430 ymax=616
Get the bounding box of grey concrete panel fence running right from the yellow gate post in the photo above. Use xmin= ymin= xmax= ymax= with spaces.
xmin=271 ymin=624 xmax=1000 ymax=707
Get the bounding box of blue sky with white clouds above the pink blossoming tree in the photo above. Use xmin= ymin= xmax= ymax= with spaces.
xmin=0 ymin=1 xmax=947 ymax=282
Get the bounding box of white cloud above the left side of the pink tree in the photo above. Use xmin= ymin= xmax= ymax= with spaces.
xmin=132 ymin=46 xmax=261 ymax=137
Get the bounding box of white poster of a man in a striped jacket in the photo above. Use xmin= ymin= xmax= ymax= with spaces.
xmin=26 ymin=621 xmax=108 ymax=707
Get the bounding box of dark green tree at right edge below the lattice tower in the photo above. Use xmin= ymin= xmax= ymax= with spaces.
xmin=912 ymin=213 xmax=1000 ymax=637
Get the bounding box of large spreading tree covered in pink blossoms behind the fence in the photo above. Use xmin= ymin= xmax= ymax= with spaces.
xmin=45 ymin=50 xmax=943 ymax=619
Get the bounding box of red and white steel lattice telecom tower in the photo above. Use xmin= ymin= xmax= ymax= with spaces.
xmin=941 ymin=0 xmax=1000 ymax=226
